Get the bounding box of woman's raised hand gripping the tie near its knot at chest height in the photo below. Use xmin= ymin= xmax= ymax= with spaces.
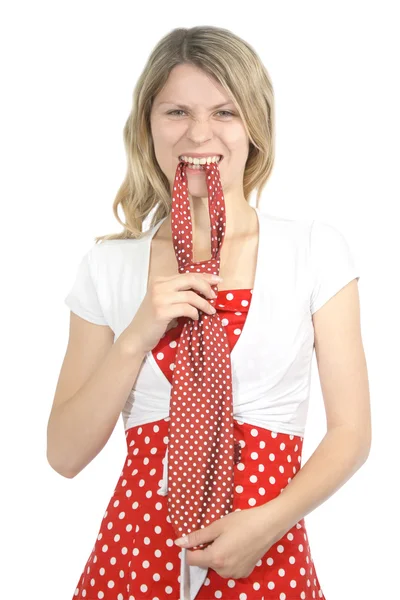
xmin=123 ymin=273 xmax=220 ymax=354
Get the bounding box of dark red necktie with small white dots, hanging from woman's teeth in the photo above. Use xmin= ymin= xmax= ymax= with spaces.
xmin=168 ymin=161 xmax=239 ymax=550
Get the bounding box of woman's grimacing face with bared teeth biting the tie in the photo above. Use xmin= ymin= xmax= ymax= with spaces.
xmin=150 ymin=64 xmax=249 ymax=199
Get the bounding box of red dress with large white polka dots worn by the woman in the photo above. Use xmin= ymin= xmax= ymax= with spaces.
xmin=73 ymin=289 xmax=325 ymax=600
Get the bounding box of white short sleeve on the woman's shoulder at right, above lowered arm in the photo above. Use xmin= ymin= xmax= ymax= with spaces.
xmin=310 ymin=220 xmax=360 ymax=314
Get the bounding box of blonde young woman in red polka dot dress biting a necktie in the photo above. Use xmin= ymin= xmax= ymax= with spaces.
xmin=48 ymin=27 xmax=371 ymax=600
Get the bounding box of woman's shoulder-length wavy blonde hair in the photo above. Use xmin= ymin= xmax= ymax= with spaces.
xmin=95 ymin=26 xmax=275 ymax=243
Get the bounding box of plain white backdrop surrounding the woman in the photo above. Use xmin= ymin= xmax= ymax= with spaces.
xmin=0 ymin=0 xmax=400 ymax=600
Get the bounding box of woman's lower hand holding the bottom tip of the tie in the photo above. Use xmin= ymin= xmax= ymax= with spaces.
xmin=175 ymin=505 xmax=283 ymax=579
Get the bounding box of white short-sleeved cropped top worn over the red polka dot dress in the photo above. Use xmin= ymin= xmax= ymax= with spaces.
xmin=65 ymin=208 xmax=359 ymax=600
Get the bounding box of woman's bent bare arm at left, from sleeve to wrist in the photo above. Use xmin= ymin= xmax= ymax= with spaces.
xmin=47 ymin=313 xmax=145 ymax=478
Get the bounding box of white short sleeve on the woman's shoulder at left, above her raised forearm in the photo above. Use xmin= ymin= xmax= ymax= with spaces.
xmin=64 ymin=247 xmax=108 ymax=325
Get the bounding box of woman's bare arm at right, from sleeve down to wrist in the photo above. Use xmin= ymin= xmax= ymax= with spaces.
xmin=264 ymin=280 xmax=371 ymax=535
